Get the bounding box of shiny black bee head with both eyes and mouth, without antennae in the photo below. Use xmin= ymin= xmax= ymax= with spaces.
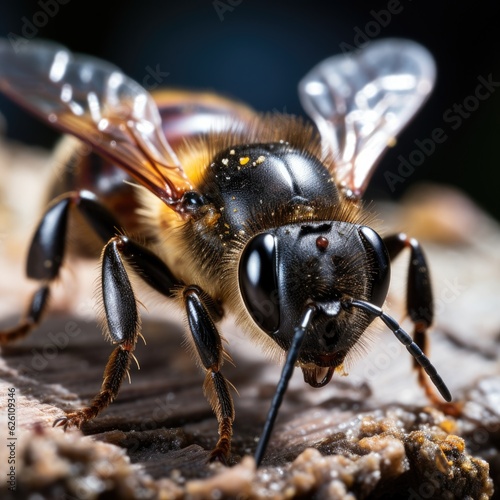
xmin=239 ymin=221 xmax=390 ymax=387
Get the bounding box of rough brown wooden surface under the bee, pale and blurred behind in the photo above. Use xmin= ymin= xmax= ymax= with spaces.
xmin=0 ymin=138 xmax=500 ymax=499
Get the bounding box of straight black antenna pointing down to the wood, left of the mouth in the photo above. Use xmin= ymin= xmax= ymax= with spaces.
xmin=255 ymin=304 xmax=316 ymax=467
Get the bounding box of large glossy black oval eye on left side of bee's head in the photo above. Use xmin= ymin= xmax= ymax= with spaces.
xmin=238 ymin=233 xmax=280 ymax=334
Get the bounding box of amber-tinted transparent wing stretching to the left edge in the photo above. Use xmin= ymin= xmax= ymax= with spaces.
xmin=0 ymin=39 xmax=191 ymax=208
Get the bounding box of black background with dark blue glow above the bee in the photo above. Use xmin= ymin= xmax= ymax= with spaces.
xmin=0 ymin=0 xmax=500 ymax=219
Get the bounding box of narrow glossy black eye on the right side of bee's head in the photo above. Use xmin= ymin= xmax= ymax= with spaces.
xmin=358 ymin=226 xmax=391 ymax=307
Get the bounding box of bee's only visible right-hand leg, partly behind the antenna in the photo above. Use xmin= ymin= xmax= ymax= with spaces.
xmin=384 ymin=233 xmax=443 ymax=406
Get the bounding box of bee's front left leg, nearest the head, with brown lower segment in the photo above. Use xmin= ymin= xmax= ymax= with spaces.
xmin=183 ymin=286 xmax=234 ymax=463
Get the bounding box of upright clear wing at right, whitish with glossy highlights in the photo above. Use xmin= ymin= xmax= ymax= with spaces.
xmin=299 ymin=39 xmax=436 ymax=198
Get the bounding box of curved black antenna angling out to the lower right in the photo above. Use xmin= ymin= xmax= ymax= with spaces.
xmin=342 ymin=300 xmax=451 ymax=402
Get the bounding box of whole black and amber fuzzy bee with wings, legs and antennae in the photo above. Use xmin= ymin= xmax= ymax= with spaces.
xmin=0 ymin=39 xmax=451 ymax=464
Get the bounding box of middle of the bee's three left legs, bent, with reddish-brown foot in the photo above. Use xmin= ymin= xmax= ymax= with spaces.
xmin=54 ymin=235 xmax=180 ymax=429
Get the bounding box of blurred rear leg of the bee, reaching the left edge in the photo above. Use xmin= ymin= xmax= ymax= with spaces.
xmin=0 ymin=191 xmax=120 ymax=345
